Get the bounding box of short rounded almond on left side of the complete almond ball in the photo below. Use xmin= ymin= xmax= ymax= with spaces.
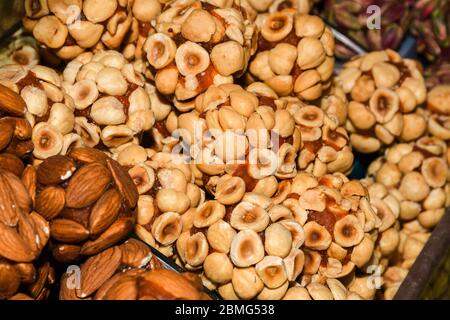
xmin=35 ymin=186 xmax=66 ymax=220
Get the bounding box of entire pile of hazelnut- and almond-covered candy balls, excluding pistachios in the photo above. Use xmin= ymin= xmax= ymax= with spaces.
xmin=0 ymin=0 xmax=450 ymax=300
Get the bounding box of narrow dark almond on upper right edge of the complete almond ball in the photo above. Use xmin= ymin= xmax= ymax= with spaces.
xmin=106 ymin=159 xmax=139 ymax=208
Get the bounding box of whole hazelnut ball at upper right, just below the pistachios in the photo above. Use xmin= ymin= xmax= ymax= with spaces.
xmin=336 ymin=49 xmax=427 ymax=153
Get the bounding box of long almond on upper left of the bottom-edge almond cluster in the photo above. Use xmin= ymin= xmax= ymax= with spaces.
xmin=77 ymin=247 xmax=122 ymax=298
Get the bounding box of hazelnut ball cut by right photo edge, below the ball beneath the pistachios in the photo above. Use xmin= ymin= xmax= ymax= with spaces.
xmin=368 ymin=137 xmax=449 ymax=229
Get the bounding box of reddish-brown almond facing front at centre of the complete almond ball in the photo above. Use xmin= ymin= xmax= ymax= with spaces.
xmin=66 ymin=163 xmax=111 ymax=208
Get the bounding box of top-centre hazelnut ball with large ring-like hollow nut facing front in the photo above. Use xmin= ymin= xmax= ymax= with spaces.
xmin=144 ymin=0 xmax=255 ymax=103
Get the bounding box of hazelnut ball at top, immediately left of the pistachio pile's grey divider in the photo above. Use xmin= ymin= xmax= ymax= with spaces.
xmin=248 ymin=11 xmax=334 ymax=101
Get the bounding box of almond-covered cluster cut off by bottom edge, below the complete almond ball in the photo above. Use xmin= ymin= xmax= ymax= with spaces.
xmin=59 ymin=239 xmax=207 ymax=300
